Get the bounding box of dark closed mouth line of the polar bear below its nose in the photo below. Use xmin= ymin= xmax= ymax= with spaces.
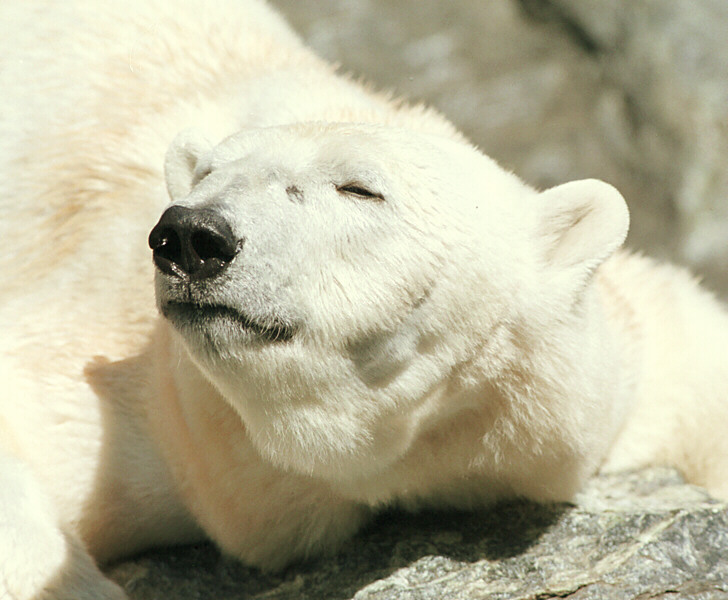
xmin=162 ymin=301 xmax=294 ymax=342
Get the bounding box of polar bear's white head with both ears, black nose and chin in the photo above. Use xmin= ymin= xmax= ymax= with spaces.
xmin=150 ymin=123 xmax=627 ymax=486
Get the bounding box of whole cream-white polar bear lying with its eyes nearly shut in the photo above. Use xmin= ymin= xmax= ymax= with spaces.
xmin=0 ymin=0 xmax=728 ymax=600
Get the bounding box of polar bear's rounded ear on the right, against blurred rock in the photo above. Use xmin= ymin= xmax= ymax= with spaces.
xmin=539 ymin=179 xmax=629 ymax=283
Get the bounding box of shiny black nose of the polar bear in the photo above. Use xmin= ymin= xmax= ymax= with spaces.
xmin=149 ymin=206 xmax=238 ymax=279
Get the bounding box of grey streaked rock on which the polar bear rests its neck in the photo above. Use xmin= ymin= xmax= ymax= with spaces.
xmin=110 ymin=469 xmax=728 ymax=600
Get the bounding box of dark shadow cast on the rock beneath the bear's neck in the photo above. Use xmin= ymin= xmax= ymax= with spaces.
xmin=110 ymin=501 xmax=567 ymax=600
